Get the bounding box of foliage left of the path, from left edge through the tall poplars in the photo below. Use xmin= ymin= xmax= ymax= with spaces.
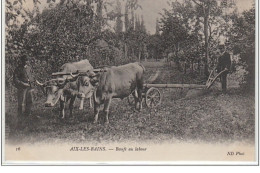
xmin=5 ymin=0 xmax=151 ymax=102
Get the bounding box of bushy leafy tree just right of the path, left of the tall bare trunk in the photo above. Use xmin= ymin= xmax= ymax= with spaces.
xmin=160 ymin=1 xmax=194 ymax=69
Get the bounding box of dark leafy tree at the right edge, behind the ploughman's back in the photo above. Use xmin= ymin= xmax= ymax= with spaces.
xmin=230 ymin=5 xmax=255 ymax=92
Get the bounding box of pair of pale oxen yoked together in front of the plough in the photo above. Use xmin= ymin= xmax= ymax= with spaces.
xmin=36 ymin=59 xmax=145 ymax=123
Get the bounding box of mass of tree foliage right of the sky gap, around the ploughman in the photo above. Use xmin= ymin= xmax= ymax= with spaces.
xmin=153 ymin=0 xmax=255 ymax=81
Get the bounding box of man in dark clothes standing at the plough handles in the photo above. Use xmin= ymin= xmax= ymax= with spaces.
xmin=217 ymin=45 xmax=231 ymax=93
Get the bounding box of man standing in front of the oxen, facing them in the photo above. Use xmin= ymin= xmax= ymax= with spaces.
xmin=13 ymin=55 xmax=34 ymax=123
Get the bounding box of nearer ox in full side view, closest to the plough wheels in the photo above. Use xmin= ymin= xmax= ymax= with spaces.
xmin=72 ymin=62 xmax=145 ymax=124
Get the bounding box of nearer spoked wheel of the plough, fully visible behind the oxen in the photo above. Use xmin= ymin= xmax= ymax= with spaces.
xmin=145 ymin=87 xmax=162 ymax=108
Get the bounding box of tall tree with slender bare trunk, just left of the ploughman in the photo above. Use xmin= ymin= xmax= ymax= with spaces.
xmin=192 ymin=0 xmax=234 ymax=76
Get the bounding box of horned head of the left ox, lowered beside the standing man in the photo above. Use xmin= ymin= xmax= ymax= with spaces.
xmin=36 ymin=78 xmax=70 ymax=107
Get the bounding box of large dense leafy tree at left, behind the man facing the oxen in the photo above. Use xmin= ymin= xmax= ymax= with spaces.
xmin=6 ymin=0 xmax=117 ymax=84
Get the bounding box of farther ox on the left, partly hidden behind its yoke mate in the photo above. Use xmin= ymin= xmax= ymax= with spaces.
xmin=37 ymin=59 xmax=94 ymax=118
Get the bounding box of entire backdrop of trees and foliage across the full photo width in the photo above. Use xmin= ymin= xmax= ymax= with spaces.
xmin=5 ymin=0 xmax=255 ymax=99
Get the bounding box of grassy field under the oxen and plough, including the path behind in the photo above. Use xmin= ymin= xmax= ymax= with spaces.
xmin=6 ymin=62 xmax=255 ymax=144
